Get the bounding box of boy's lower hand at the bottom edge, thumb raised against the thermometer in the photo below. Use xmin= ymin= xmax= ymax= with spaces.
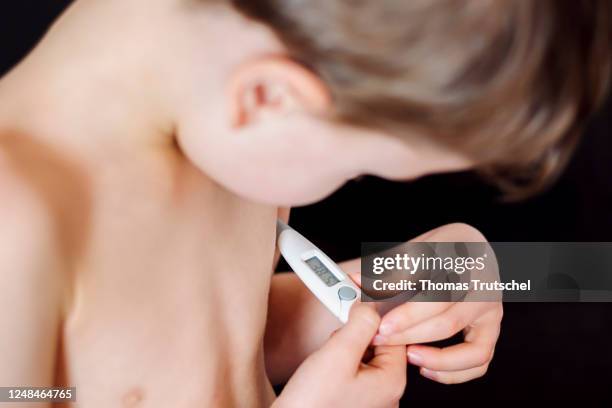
xmin=273 ymin=303 xmax=406 ymax=407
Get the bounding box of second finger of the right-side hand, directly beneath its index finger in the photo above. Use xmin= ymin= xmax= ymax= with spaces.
xmin=386 ymin=302 xmax=492 ymax=345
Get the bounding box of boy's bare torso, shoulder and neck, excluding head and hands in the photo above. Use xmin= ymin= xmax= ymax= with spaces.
xmin=0 ymin=1 xmax=277 ymax=407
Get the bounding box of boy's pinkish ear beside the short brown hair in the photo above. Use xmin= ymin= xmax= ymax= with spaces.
xmin=228 ymin=56 xmax=331 ymax=127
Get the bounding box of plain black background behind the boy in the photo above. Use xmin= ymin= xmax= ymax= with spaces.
xmin=0 ymin=0 xmax=612 ymax=406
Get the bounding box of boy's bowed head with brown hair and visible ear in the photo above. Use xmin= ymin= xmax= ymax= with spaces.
xmin=157 ymin=0 xmax=612 ymax=205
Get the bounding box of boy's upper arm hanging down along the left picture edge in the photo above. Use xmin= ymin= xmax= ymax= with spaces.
xmin=0 ymin=182 xmax=61 ymax=398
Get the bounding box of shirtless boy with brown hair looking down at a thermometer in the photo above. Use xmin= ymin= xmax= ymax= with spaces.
xmin=0 ymin=0 xmax=609 ymax=407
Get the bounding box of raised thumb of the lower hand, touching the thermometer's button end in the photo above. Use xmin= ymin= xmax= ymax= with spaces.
xmin=321 ymin=303 xmax=380 ymax=368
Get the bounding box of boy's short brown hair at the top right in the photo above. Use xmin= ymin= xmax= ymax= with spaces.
xmin=232 ymin=0 xmax=612 ymax=196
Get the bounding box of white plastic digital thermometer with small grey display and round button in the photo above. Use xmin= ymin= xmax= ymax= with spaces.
xmin=276 ymin=220 xmax=361 ymax=323
